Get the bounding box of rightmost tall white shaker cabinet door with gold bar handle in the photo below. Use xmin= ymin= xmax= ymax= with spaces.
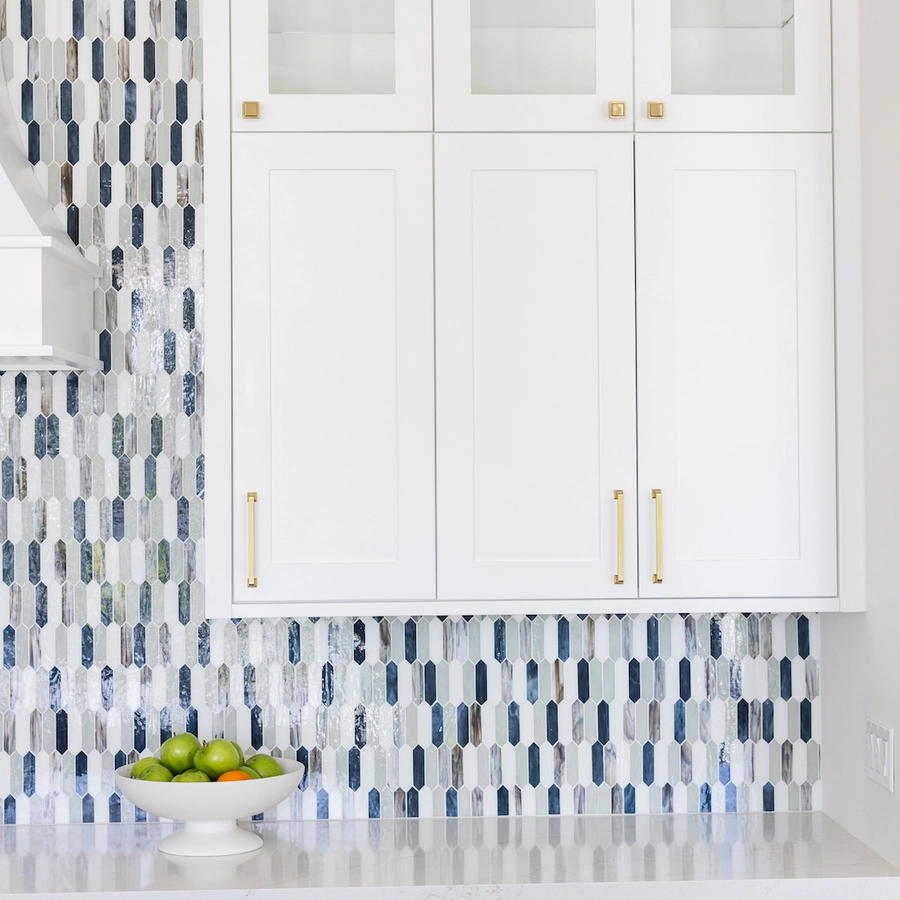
xmin=636 ymin=134 xmax=837 ymax=605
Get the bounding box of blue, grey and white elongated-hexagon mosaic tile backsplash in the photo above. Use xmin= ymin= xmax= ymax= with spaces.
xmin=0 ymin=0 xmax=820 ymax=823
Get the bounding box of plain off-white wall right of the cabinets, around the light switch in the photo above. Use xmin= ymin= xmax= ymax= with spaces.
xmin=822 ymin=0 xmax=900 ymax=866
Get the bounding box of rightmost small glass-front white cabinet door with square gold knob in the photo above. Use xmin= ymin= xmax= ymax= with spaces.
xmin=634 ymin=0 xmax=831 ymax=131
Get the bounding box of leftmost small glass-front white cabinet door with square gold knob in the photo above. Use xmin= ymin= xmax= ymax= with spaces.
xmin=231 ymin=0 xmax=432 ymax=131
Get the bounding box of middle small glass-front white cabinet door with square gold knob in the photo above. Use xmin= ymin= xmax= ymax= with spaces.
xmin=434 ymin=0 xmax=633 ymax=131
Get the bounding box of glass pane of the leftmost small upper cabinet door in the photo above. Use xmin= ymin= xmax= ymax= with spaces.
xmin=269 ymin=0 xmax=395 ymax=94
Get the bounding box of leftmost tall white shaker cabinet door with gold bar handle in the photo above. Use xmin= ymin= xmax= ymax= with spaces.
xmin=232 ymin=134 xmax=435 ymax=604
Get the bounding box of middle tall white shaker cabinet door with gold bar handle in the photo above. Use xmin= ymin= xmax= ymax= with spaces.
xmin=435 ymin=134 xmax=637 ymax=608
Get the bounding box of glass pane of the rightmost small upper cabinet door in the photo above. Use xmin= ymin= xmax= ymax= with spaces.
xmin=671 ymin=0 xmax=794 ymax=95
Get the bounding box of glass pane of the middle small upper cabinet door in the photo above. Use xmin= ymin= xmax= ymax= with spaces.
xmin=470 ymin=0 xmax=597 ymax=94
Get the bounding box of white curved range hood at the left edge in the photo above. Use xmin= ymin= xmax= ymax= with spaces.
xmin=0 ymin=67 xmax=103 ymax=371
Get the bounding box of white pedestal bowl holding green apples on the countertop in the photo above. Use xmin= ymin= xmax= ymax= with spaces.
xmin=116 ymin=759 xmax=305 ymax=856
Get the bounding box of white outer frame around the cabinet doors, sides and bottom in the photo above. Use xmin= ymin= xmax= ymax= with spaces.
xmin=198 ymin=0 xmax=866 ymax=618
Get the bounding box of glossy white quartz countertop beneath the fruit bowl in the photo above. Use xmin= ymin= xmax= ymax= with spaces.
xmin=0 ymin=813 xmax=900 ymax=900
